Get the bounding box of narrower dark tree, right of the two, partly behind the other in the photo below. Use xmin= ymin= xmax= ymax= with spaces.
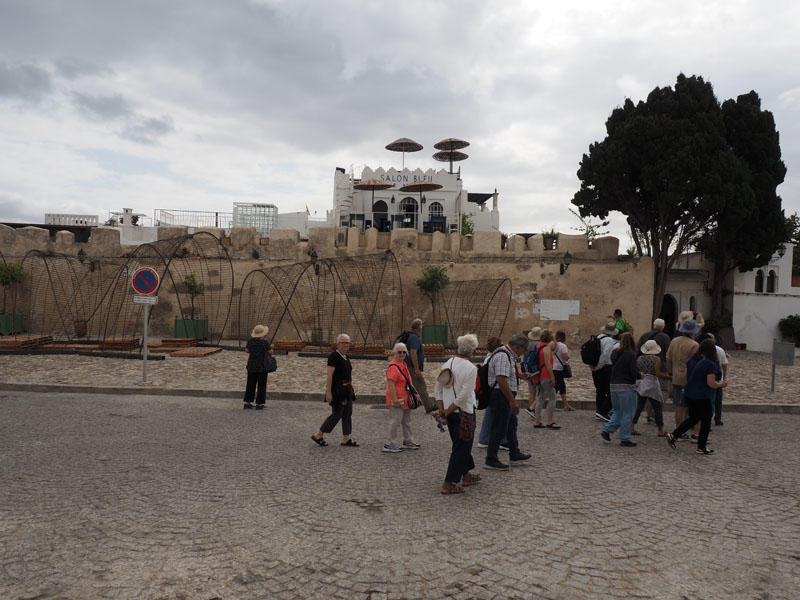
xmin=697 ymin=91 xmax=790 ymax=315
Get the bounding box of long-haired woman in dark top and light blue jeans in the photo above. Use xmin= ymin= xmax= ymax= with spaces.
xmin=600 ymin=333 xmax=641 ymax=447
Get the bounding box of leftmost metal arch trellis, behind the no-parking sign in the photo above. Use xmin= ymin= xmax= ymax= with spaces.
xmin=14 ymin=232 xmax=233 ymax=343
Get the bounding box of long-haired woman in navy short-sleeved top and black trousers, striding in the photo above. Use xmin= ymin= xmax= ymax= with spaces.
xmin=666 ymin=338 xmax=728 ymax=454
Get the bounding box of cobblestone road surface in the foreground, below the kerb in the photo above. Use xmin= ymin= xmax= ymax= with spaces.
xmin=0 ymin=392 xmax=800 ymax=600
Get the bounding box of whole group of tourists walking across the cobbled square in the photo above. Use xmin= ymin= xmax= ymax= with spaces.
xmin=244 ymin=310 xmax=727 ymax=494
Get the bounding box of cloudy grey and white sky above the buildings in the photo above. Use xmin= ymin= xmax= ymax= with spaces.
xmin=0 ymin=0 xmax=800 ymax=241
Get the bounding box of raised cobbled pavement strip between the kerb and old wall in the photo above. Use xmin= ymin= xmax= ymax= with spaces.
xmin=0 ymin=349 xmax=800 ymax=404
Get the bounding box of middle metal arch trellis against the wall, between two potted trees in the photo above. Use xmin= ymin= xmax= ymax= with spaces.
xmin=238 ymin=252 xmax=403 ymax=347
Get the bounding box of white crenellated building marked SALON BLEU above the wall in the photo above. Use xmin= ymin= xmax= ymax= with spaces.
xmin=331 ymin=167 xmax=500 ymax=233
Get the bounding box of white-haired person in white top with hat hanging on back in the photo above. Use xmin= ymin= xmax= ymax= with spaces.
xmin=434 ymin=333 xmax=481 ymax=494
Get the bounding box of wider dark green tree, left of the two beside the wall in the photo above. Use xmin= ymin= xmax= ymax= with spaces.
xmin=572 ymin=74 xmax=784 ymax=316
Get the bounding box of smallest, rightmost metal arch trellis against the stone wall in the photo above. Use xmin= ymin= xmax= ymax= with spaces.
xmin=440 ymin=278 xmax=512 ymax=346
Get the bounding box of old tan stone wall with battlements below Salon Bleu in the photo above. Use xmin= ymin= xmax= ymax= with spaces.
xmin=0 ymin=225 xmax=654 ymax=342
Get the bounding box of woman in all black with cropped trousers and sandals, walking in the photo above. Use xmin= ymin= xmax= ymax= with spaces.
xmin=311 ymin=333 xmax=361 ymax=448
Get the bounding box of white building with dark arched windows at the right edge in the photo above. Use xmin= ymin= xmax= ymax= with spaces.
xmin=733 ymin=244 xmax=800 ymax=352
